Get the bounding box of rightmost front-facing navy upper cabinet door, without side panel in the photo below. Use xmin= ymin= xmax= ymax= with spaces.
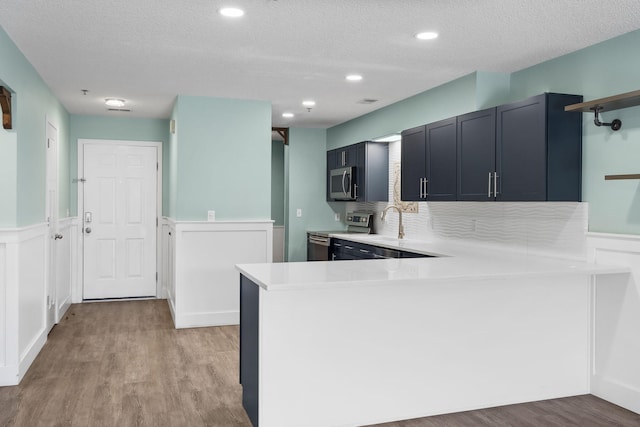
xmin=496 ymin=95 xmax=547 ymax=201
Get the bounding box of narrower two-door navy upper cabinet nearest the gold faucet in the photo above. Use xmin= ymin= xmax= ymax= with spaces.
xmin=401 ymin=117 xmax=457 ymax=201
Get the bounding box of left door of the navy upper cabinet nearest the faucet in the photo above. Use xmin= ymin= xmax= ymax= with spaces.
xmin=400 ymin=126 xmax=427 ymax=202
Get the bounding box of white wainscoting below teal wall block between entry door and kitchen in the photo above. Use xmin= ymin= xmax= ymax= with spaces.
xmin=163 ymin=219 xmax=273 ymax=328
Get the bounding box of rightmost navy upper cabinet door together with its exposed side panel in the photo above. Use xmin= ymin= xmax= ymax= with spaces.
xmin=495 ymin=93 xmax=582 ymax=201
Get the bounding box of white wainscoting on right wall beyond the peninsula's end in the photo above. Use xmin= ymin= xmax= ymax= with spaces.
xmin=587 ymin=233 xmax=640 ymax=413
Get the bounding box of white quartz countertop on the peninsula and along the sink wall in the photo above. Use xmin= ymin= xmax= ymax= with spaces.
xmin=236 ymin=234 xmax=629 ymax=291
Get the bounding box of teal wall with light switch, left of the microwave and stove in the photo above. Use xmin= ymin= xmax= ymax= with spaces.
xmin=285 ymin=128 xmax=344 ymax=261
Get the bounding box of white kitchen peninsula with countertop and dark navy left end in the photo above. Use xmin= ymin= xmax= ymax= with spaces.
xmin=237 ymin=235 xmax=628 ymax=427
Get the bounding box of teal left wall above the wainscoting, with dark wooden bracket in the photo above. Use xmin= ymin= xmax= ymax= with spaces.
xmin=0 ymin=28 xmax=69 ymax=228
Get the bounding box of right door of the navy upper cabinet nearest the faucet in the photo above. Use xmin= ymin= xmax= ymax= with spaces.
xmin=428 ymin=117 xmax=458 ymax=201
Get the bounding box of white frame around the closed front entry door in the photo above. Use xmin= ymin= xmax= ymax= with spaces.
xmin=72 ymin=138 xmax=165 ymax=302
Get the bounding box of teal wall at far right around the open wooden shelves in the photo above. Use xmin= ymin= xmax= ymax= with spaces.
xmin=511 ymin=31 xmax=640 ymax=234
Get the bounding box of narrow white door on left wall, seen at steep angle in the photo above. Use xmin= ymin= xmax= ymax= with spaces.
xmin=45 ymin=121 xmax=61 ymax=332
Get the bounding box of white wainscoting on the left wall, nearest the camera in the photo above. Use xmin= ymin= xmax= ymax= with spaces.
xmin=0 ymin=224 xmax=48 ymax=386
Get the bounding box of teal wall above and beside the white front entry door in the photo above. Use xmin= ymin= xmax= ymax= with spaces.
xmin=66 ymin=114 xmax=169 ymax=216
